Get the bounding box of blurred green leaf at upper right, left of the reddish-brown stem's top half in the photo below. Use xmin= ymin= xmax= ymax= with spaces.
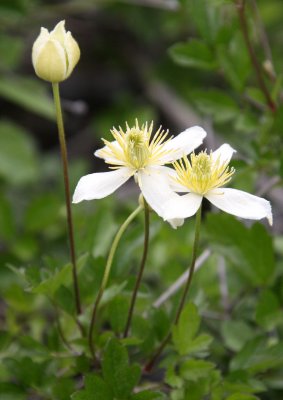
xmin=169 ymin=39 xmax=216 ymax=70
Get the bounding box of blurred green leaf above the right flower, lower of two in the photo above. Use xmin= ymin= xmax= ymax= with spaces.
xmin=193 ymin=89 xmax=239 ymax=123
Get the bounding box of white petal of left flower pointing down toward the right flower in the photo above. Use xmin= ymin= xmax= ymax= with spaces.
xmin=137 ymin=167 xmax=180 ymax=217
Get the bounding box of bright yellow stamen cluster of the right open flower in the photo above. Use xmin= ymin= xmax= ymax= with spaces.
xmin=173 ymin=151 xmax=235 ymax=195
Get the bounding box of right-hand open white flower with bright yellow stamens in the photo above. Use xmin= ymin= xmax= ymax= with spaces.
xmin=164 ymin=144 xmax=272 ymax=225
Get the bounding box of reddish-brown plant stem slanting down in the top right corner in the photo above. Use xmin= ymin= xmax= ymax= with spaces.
xmin=235 ymin=0 xmax=276 ymax=112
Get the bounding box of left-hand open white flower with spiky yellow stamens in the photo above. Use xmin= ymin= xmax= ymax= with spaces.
xmin=73 ymin=120 xmax=206 ymax=227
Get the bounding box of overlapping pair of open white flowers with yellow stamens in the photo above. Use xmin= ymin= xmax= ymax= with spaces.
xmin=73 ymin=121 xmax=272 ymax=228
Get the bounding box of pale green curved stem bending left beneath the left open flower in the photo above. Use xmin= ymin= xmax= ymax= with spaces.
xmin=88 ymin=206 xmax=143 ymax=359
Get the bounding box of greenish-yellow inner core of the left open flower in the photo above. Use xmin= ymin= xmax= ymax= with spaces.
xmin=126 ymin=127 xmax=150 ymax=169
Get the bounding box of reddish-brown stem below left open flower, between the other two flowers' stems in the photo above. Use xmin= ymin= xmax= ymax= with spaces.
xmin=124 ymin=199 xmax=149 ymax=338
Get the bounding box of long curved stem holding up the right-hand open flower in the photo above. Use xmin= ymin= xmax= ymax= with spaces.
xmin=144 ymin=206 xmax=201 ymax=372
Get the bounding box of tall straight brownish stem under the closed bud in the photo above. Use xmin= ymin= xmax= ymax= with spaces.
xmin=52 ymin=83 xmax=81 ymax=315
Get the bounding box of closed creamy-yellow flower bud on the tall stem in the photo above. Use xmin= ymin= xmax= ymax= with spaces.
xmin=32 ymin=21 xmax=80 ymax=83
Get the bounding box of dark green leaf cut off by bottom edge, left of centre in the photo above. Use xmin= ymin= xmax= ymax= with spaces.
xmin=71 ymin=374 xmax=113 ymax=400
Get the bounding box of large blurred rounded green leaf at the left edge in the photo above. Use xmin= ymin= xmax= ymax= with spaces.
xmin=0 ymin=121 xmax=39 ymax=185
